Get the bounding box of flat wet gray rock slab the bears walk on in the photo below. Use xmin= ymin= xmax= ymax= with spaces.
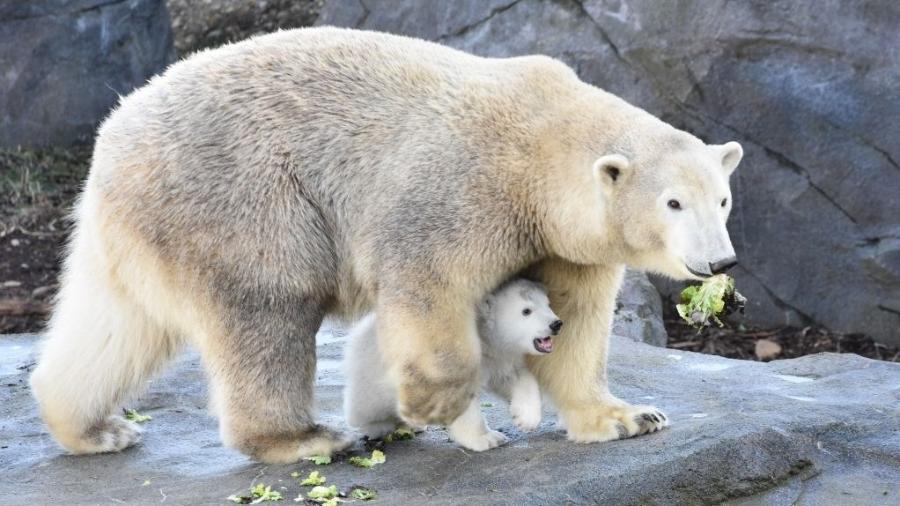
xmin=0 ymin=329 xmax=900 ymax=506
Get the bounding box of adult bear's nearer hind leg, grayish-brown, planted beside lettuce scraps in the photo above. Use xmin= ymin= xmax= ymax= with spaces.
xmin=207 ymin=295 xmax=352 ymax=464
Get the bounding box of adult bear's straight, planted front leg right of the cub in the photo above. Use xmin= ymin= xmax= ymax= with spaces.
xmin=528 ymin=260 xmax=669 ymax=443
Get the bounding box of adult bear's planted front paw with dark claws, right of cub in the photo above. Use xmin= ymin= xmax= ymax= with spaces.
xmin=563 ymin=403 xmax=669 ymax=443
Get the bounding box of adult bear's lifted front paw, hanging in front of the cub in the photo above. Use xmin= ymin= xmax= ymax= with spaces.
xmin=397 ymin=367 xmax=478 ymax=427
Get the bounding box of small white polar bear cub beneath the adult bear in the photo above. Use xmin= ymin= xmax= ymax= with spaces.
xmin=344 ymin=279 xmax=563 ymax=451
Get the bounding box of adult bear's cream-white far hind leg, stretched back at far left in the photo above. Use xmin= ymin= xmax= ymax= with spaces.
xmin=31 ymin=225 xmax=181 ymax=454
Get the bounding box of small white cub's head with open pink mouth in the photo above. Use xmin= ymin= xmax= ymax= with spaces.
xmin=481 ymin=279 xmax=563 ymax=355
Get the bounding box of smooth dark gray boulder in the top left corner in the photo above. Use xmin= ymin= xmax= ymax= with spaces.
xmin=0 ymin=0 xmax=172 ymax=147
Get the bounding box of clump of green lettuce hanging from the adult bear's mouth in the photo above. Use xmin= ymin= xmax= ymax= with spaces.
xmin=675 ymin=274 xmax=747 ymax=328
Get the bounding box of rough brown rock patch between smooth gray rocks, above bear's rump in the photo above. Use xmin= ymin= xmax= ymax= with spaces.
xmin=166 ymin=0 xmax=323 ymax=55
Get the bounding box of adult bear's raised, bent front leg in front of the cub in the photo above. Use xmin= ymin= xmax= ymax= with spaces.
xmin=377 ymin=294 xmax=481 ymax=426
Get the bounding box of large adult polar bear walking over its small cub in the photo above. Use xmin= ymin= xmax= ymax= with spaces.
xmin=32 ymin=28 xmax=742 ymax=462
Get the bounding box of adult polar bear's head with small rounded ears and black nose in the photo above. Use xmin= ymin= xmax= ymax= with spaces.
xmin=593 ymin=132 xmax=743 ymax=279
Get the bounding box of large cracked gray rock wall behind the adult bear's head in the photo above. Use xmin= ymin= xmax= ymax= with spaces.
xmin=318 ymin=0 xmax=900 ymax=343
